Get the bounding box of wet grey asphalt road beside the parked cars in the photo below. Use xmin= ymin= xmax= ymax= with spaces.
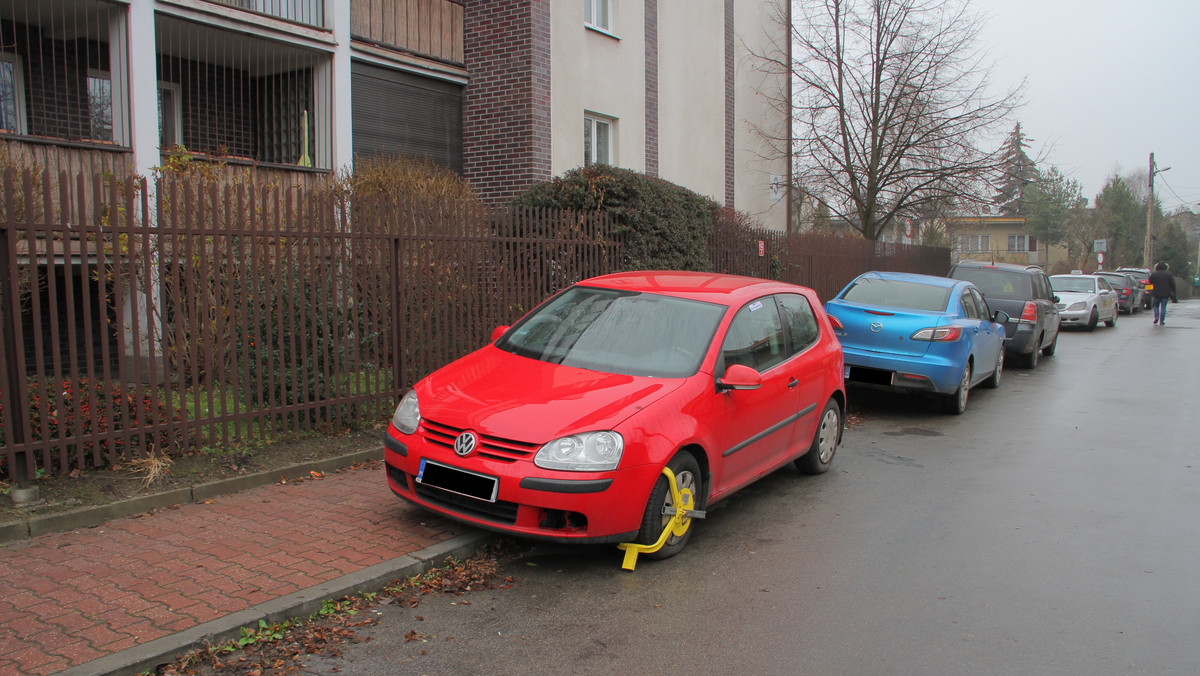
xmin=307 ymin=301 xmax=1200 ymax=676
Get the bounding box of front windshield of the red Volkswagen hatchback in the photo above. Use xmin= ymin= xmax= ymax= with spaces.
xmin=496 ymin=286 xmax=727 ymax=378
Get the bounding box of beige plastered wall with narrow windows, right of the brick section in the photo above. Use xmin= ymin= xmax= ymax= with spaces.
xmin=551 ymin=0 xmax=787 ymax=229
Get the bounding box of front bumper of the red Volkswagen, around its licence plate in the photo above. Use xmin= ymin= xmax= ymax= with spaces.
xmin=384 ymin=425 xmax=661 ymax=543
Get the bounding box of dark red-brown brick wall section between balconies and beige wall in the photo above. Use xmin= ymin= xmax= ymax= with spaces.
xmin=463 ymin=0 xmax=551 ymax=204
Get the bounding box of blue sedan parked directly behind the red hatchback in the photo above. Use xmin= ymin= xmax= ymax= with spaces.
xmin=826 ymin=273 xmax=1009 ymax=414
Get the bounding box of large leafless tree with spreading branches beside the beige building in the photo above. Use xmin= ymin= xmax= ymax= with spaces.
xmin=760 ymin=0 xmax=1024 ymax=239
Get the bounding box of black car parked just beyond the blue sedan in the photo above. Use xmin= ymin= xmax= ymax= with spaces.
xmin=949 ymin=261 xmax=1062 ymax=369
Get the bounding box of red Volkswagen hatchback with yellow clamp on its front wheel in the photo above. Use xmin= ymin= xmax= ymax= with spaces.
xmin=384 ymin=271 xmax=846 ymax=558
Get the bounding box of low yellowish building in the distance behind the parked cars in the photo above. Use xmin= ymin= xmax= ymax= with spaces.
xmin=946 ymin=215 xmax=1069 ymax=274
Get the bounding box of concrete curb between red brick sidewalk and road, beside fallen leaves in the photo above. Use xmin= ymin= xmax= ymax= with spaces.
xmin=59 ymin=531 xmax=494 ymax=676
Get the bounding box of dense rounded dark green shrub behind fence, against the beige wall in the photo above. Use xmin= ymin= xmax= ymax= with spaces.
xmin=514 ymin=164 xmax=719 ymax=270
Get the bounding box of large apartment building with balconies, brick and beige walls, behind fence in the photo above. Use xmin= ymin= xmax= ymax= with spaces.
xmin=0 ymin=0 xmax=790 ymax=228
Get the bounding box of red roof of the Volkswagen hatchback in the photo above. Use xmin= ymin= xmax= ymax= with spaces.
xmin=578 ymin=270 xmax=806 ymax=305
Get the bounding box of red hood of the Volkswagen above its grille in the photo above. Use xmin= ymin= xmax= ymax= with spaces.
xmin=415 ymin=346 xmax=686 ymax=443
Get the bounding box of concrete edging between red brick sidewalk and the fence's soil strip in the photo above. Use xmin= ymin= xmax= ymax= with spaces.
xmin=0 ymin=448 xmax=383 ymax=545
